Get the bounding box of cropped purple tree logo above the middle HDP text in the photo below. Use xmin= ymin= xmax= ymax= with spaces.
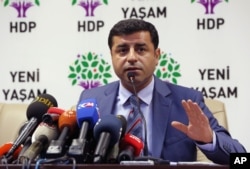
xmin=72 ymin=0 xmax=108 ymax=16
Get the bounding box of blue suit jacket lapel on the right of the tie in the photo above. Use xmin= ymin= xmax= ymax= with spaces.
xmin=152 ymin=78 xmax=172 ymax=157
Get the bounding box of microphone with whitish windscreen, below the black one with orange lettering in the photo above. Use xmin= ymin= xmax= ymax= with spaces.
xmin=20 ymin=122 xmax=58 ymax=164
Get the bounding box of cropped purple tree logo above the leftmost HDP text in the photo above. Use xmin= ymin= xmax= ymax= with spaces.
xmin=3 ymin=0 xmax=40 ymax=18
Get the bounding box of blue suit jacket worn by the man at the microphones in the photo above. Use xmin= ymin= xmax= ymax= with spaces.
xmin=79 ymin=77 xmax=245 ymax=164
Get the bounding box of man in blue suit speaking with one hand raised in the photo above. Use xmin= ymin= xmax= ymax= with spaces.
xmin=80 ymin=19 xmax=246 ymax=164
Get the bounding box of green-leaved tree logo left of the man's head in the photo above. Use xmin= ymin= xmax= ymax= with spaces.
xmin=68 ymin=52 xmax=112 ymax=89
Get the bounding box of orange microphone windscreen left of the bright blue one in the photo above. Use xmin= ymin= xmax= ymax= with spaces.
xmin=58 ymin=110 xmax=77 ymax=133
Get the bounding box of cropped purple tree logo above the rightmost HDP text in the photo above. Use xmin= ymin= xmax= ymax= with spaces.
xmin=191 ymin=0 xmax=229 ymax=14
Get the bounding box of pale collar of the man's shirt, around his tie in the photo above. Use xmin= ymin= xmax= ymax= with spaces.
xmin=118 ymin=76 xmax=154 ymax=105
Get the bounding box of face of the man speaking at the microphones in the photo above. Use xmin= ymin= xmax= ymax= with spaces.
xmin=111 ymin=31 xmax=160 ymax=91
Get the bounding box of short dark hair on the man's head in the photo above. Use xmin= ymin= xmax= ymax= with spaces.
xmin=108 ymin=19 xmax=159 ymax=49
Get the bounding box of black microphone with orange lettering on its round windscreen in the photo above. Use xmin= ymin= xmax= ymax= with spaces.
xmin=6 ymin=94 xmax=57 ymax=158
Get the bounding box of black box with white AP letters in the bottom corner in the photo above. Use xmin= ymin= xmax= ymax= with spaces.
xmin=230 ymin=153 xmax=250 ymax=169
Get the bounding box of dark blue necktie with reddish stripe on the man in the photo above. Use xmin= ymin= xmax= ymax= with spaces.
xmin=127 ymin=95 xmax=143 ymax=141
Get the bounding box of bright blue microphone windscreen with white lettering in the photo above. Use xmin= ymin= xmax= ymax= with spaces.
xmin=76 ymin=99 xmax=99 ymax=128
